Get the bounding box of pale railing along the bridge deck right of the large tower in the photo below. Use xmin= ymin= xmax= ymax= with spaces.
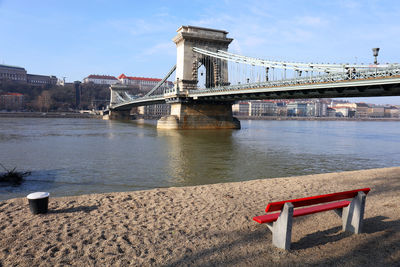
xmin=189 ymin=65 xmax=400 ymax=94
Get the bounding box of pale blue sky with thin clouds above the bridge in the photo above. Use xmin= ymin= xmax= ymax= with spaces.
xmin=0 ymin=0 xmax=400 ymax=105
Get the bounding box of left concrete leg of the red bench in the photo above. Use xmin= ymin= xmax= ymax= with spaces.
xmin=267 ymin=203 xmax=294 ymax=249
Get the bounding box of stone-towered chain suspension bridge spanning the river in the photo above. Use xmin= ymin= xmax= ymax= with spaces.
xmin=108 ymin=26 xmax=400 ymax=129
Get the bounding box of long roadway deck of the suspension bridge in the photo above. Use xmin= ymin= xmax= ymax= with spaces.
xmin=110 ymin=75 xmax=400 ymax=110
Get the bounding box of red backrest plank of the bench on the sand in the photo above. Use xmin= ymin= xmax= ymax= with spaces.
xmin=265 ymin=188 xmax=371 ymax=212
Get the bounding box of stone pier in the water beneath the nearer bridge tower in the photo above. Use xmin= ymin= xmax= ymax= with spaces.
xmin=157 ymin=102 xmax=240 ymax=129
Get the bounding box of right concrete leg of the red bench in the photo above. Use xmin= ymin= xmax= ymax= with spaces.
xmin=342 ymin=192 xmax=367 ymax=234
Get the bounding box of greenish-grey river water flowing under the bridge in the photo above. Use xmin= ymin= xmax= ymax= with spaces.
xmin=0 ymin=118 xmax=400 ymax=200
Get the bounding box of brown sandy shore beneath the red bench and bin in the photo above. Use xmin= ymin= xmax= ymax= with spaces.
xmin=0 ymin=167 xmax=400 ymax=266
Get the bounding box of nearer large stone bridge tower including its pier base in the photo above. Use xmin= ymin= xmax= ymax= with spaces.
xmin=157 ymin=26 xmax=240 ymax=129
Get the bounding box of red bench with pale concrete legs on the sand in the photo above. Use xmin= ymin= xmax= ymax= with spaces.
xmin=253 ymin=188 xmax=371 ymax=249
